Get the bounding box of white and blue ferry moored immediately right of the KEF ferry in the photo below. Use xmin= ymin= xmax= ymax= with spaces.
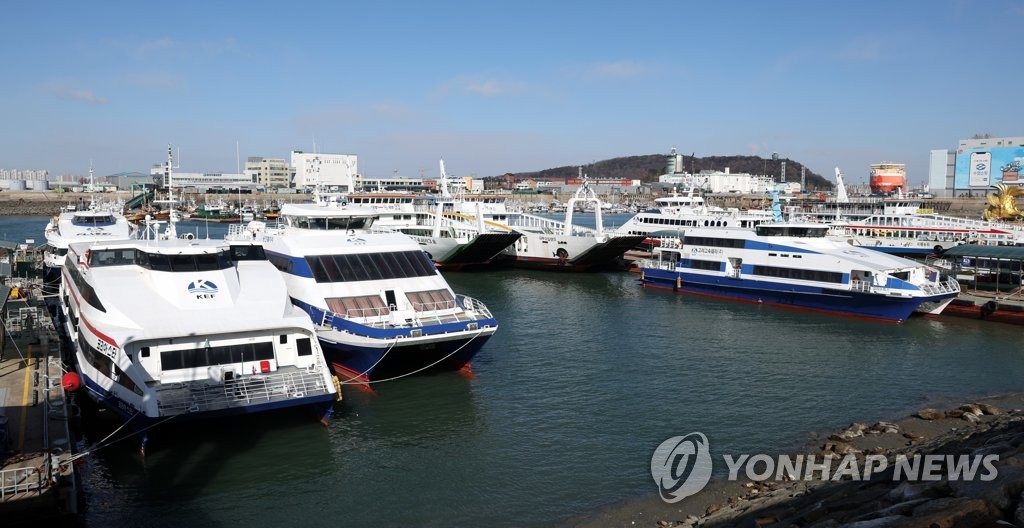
xmin=233 ymin=189 xmax=498 ymax=383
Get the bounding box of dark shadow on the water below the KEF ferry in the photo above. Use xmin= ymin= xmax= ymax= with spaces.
xmin=77 ymin=398 xmax=340 ymax=527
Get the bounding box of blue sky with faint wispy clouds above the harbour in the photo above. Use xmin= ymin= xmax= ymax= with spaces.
xmin=0 ymin=0 xmax=1024 ymax=184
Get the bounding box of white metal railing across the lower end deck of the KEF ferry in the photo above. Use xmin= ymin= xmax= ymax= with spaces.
xmin=158 ymin=366 xmax=329 ymax=415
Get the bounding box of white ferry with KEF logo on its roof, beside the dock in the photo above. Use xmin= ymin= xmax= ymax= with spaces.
xmin=60 ymin=227 xmax=340 ymax=433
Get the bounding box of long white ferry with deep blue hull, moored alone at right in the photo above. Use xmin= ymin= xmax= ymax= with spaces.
xmin=640 ymin=213 xmax=959 ymax=322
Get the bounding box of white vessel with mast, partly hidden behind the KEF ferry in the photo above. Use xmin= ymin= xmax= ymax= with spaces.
xmin=43 ymin=167 xmax=134 ymax=293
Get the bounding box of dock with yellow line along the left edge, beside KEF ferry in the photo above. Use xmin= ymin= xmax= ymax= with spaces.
xmin=0 ymin=284 xmax=78 ymax=527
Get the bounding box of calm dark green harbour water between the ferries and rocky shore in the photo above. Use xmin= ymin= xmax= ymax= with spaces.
xmin=0 ymin=217 xmax=1024 ymax=527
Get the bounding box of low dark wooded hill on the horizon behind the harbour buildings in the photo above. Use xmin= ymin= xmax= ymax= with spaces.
xmin=501 ymin=155 xmax=835 ymax=190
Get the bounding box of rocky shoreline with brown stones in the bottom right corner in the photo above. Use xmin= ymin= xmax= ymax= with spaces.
xmin=571 ymin=394 xmax=1024 ymax=528
